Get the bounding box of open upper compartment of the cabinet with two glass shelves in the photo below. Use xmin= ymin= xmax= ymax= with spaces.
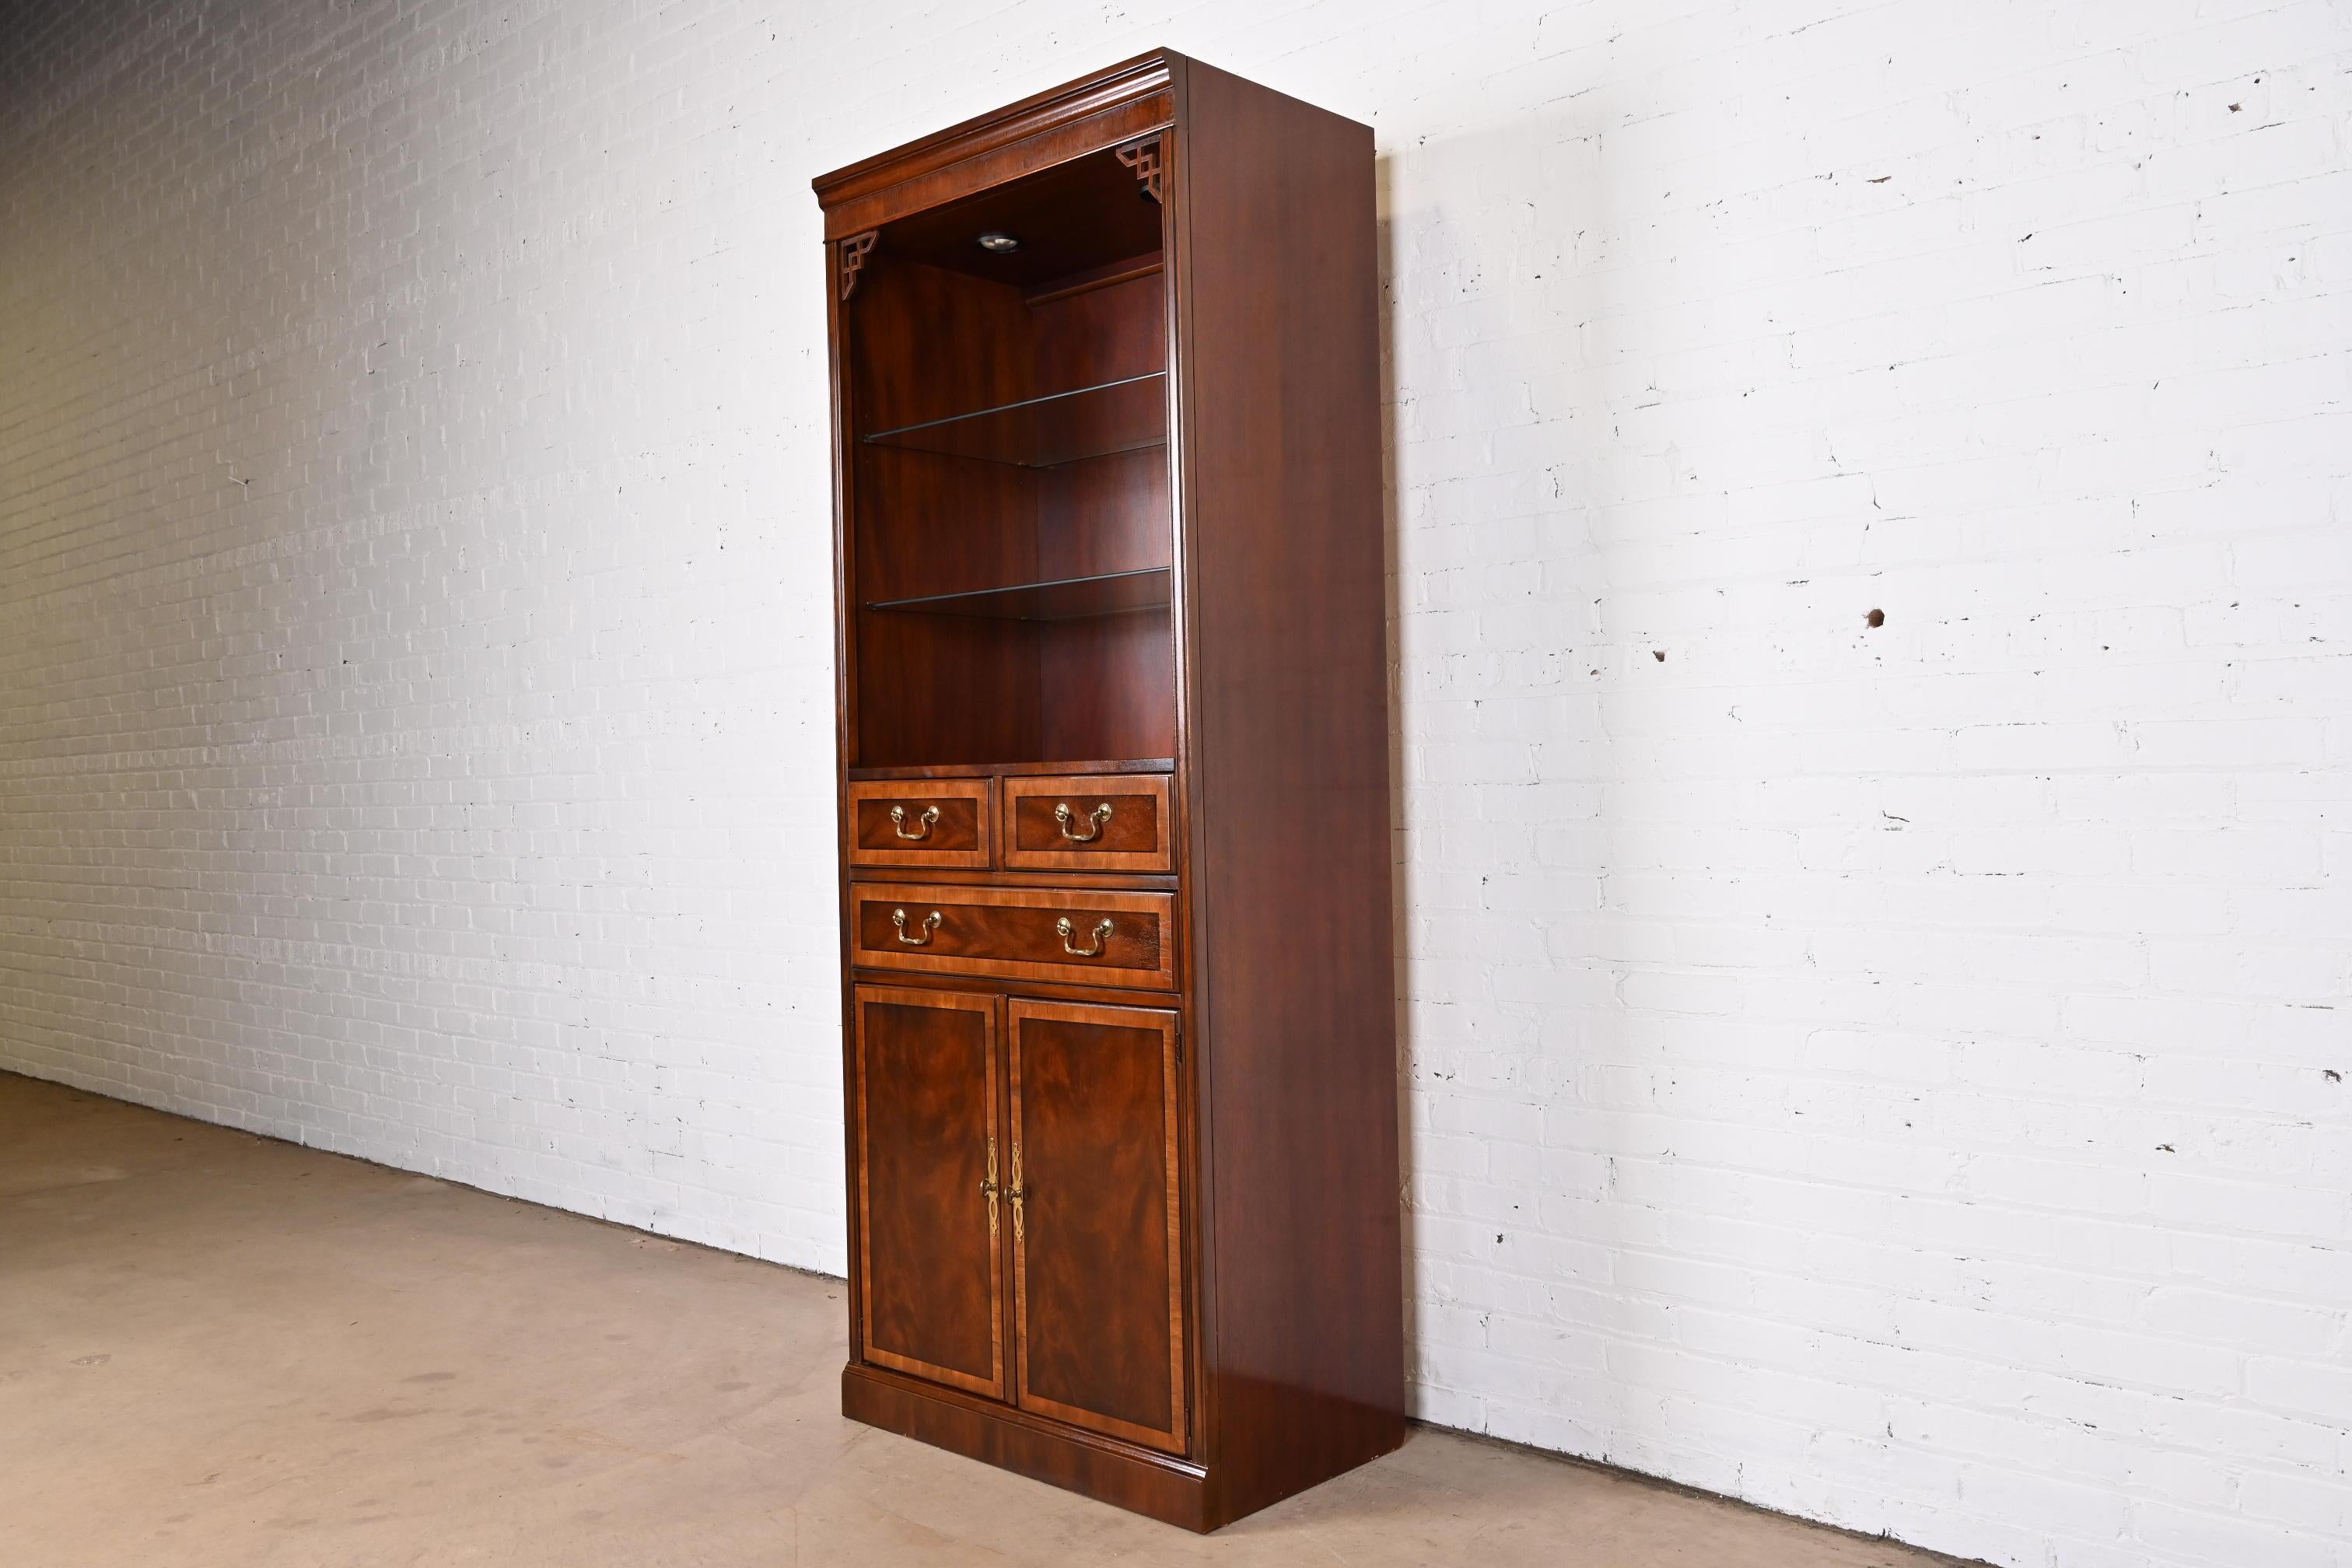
xmin=838 ymin=148 xmax=1176 ymax=768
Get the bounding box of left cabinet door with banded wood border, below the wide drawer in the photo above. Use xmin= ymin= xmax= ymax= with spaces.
xmin=856 ymin=985 xmax=1004 ymax=1398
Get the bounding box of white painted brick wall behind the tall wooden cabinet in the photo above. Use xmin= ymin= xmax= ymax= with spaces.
xmin=0 ymin=0 xmax=2352 ymax=1568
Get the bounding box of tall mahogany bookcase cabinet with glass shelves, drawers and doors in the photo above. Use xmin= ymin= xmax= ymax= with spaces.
xmin=816 ymin=51 xmax=1404 ymax=1531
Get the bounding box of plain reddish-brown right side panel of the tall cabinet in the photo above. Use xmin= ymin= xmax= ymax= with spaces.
xmin=1174 ymin=61 xmax=1404 ymax=1517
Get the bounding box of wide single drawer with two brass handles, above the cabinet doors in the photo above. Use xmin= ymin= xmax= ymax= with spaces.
xmin=852 ymin=881 xmax=1176 ymax=989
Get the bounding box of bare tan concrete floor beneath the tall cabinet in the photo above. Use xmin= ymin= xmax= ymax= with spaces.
xmin=0 ymin=1074 xmax=1948 ymax=1568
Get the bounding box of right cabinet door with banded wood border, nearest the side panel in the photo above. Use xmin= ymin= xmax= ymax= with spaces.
xmin=1006 ymin=1002 xmax=1185 ymax=1453
